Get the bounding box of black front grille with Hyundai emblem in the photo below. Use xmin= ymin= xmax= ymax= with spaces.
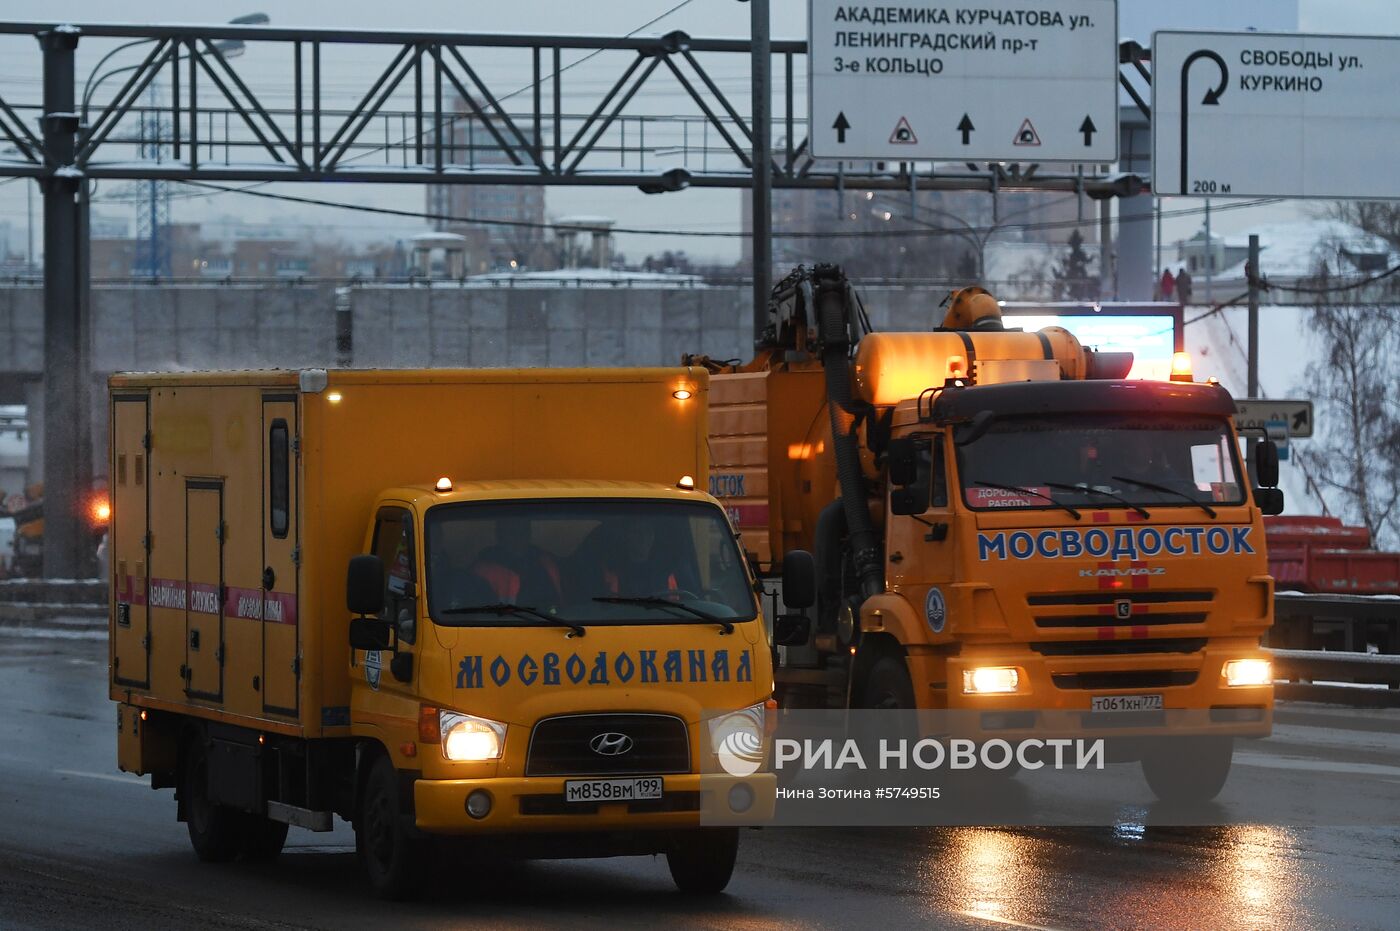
xmin=525 ymin=714 xmax=690 ymax=776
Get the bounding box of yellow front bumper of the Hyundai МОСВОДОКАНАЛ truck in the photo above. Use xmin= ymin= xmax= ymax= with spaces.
xmin=413 ymin=773 xmax=777 ymax=834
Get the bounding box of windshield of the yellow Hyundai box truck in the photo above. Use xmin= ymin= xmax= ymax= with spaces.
xmin=424 ymin=498 xmax=756 ymax=627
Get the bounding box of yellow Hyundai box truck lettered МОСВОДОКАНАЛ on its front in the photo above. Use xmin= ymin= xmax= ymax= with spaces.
xmin=109 ymin=368 xmax=773 ymax=896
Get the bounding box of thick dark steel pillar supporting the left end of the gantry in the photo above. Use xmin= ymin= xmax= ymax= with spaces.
xmin=38 ymin=27 xmax=92 ymax=578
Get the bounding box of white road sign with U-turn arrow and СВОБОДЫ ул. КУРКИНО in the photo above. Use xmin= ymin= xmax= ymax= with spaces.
xmin=1152 ymin=32 xmax=1400 ymax=197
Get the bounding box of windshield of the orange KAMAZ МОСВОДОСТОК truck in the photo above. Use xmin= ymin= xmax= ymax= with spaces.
xmin=958 ymin=414 xmax=1245 ymax=511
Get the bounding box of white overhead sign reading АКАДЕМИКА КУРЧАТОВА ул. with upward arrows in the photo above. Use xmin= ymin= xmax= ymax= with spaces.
xmin=808 ymin=0 xmax=1119 ymax=162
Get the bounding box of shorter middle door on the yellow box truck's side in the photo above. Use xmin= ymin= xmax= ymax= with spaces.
xmin=185 ymin=479 xmax=224 ymax=701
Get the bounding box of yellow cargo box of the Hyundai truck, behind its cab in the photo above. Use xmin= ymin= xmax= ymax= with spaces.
xmin=111 ymin=368 xmax=708 ymax=736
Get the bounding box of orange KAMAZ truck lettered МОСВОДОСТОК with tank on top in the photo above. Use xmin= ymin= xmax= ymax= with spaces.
xmin=690 ymin=266 xmax=1282 ymax=798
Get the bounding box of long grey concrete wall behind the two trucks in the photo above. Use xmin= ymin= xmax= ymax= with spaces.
xmin=0 ymin=277 xmax=944 ymax=476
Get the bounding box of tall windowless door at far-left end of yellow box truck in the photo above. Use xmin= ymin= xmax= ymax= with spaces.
xmin=106 ymin=395 xmax=151 ymax=689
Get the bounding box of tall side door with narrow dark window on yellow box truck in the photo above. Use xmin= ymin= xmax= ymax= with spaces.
xmin=262 ymin=395 xmax=301 ymax=717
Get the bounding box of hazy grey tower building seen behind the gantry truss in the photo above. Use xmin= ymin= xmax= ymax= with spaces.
xmin=427 ymin=97 xmax=552 ymax=274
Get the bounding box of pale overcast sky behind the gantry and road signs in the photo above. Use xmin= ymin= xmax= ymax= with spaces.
xmin=0 ymin=0 xmax=1400 ymax=260
